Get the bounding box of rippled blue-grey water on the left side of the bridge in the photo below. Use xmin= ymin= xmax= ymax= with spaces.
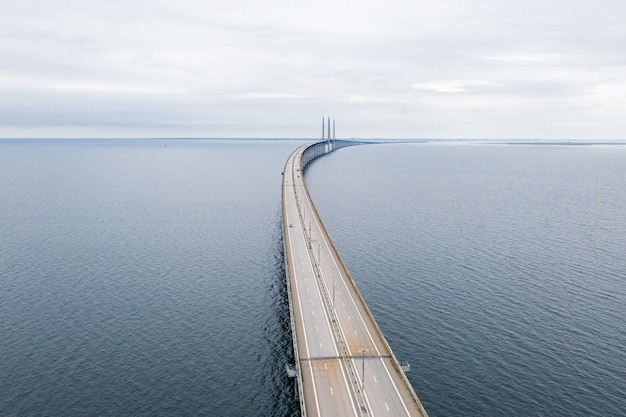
xmin=0 ymin=140 xmax=301 ymax=417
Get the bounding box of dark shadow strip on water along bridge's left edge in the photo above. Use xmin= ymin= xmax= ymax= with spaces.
xmin=262 ymin=208 xmax=300 ymax=416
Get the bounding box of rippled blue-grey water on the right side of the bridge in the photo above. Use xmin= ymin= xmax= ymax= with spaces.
xmin=308 ymin=144 xmax=626 ymax=417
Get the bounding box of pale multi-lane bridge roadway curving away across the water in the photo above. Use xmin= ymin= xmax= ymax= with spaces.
xmin=283 ymin=143 xmax=427 ymax=417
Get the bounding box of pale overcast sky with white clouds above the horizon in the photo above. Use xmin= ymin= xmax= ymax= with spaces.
xmin=0 ymin=0 xmax=626 ymax=139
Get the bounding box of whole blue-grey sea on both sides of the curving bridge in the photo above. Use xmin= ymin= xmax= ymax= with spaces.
xmin=0 ymin=139 xmax=626 ymax=417
